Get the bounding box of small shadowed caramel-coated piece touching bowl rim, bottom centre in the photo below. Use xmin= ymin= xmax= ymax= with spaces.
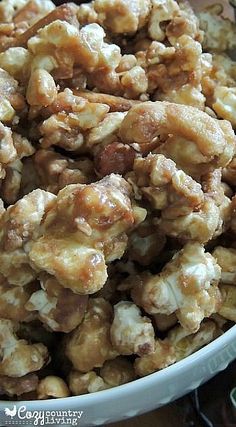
xmin=100 ymin=357 xmax=135 ymax=387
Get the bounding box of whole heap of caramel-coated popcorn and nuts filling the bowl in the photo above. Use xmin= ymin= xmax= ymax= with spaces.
xmin=0 ymin=0 xmax=236 ymax=400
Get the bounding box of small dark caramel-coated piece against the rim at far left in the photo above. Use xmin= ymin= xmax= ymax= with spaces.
xmin=0 ymin=374 xmax=39 ymax=397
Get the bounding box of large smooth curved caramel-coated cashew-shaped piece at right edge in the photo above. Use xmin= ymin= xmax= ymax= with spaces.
xmin=120 ymin=101 xmax=235 ymax=176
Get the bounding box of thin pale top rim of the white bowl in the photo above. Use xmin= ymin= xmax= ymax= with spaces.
xmin=0 ymin=325 xmax=236 ymax=410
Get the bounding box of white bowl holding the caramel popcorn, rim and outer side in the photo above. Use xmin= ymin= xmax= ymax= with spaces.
xmin=0 ymin=326 xmax=236 ymax=427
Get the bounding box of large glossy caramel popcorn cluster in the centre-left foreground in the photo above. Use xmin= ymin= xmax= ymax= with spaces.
xmin=29 ymin=175 xmax=138 ymax=294
